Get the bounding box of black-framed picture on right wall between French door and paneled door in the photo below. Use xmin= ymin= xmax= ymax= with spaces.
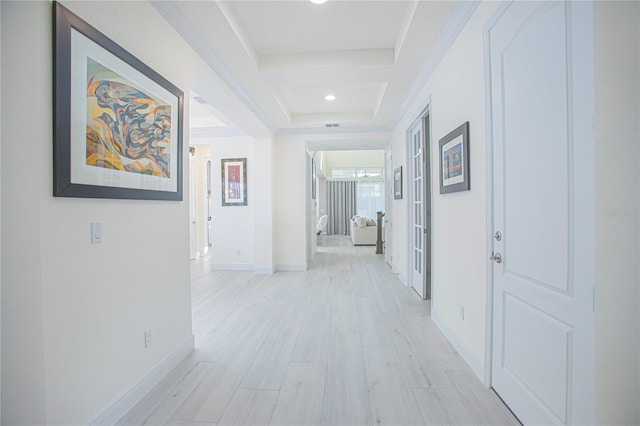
xmin=439 ymin=121 xmax=471 ymax=194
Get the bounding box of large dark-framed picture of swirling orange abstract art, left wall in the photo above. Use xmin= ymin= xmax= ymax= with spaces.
xmin=53 ymin=2 xmax=184 ymax=201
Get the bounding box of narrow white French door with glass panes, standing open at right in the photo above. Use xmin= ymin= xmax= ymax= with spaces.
xmin=407 ymin=120 xmax=426 ymax=299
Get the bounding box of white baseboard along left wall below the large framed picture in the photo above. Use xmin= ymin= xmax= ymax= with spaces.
xmin=87 ymin=334 xmax=194 ymax=425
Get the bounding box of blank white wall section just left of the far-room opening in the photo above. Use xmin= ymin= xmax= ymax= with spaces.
xmin=274 ymin=136 xmax=309 ymax=271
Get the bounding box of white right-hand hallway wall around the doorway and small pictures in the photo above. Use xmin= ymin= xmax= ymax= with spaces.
xmin=392 ymin=2 xmax=497 ymax=377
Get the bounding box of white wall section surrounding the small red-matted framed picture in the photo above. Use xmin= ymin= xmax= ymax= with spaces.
xmin=211 ymin=138 xmax=256 ymax=270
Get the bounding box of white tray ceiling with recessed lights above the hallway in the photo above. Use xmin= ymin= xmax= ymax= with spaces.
xmin=161 ymin=0 xmax=456 ymax=149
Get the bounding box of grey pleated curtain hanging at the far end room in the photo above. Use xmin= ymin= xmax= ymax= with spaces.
xmin=327 ymin=181 xmax=356 ymax=235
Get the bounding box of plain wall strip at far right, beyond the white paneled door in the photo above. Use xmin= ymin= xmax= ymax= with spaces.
xmin=594 ymin=2 xmax=640 ymax=425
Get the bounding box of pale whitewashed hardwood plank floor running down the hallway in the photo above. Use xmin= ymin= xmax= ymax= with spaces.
xmin=119 ymin=236 xmax=518 ymax=426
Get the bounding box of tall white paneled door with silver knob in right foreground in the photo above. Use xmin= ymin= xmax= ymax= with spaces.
xmin=487 ymin=2 xmax=594 ymax=425
